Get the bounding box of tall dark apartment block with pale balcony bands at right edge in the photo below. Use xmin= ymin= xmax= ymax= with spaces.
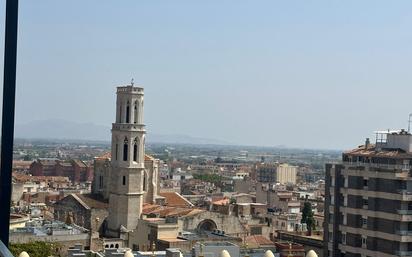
xmin=324 ymin=130 xmax=412 ymax=257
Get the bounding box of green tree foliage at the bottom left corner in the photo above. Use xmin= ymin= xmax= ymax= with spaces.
xmin=9 ymin=241 xmax=60 ymax=257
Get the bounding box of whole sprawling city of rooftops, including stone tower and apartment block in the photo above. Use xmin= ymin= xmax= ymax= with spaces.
xmin=10 ymin=83 xmax=412 ymax=257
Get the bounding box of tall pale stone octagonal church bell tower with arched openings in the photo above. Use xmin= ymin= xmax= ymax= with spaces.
xmin=106 ymin=83 xmax=146 ymax=237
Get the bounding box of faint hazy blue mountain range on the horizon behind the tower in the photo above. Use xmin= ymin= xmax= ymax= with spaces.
xmin=15 ymin=119 xmax=232 ymax=145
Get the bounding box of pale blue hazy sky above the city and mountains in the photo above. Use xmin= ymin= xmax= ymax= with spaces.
xmin=1 ymin=0 xmax=412 ymax=149
